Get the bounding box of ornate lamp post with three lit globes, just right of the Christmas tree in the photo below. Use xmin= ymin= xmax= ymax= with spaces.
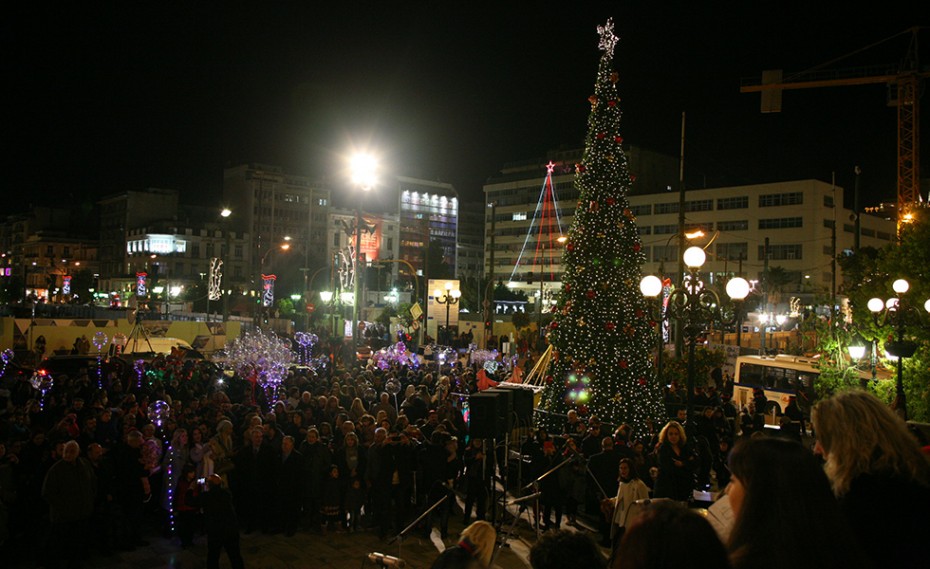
xmin=640 ymin=247 xmax=749 ymax=432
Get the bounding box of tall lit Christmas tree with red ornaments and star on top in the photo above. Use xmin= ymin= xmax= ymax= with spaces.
xmin=541 ymin=20 xmax=664 ymax=433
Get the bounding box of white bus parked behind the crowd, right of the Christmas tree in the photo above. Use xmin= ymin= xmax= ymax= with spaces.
xmin=733 ymin=355 xmax=820 ymax=424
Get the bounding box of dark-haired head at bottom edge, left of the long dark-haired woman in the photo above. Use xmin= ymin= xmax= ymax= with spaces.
xmin=610 ymin=500 xmax=730 ymax=569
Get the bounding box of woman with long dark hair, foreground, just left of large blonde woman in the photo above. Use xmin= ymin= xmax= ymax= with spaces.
xmin=727 ymin=437 xmax=868 ymax=569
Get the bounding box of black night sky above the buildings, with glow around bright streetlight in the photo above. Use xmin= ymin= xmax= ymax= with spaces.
xmin=0 ymin=0 xmax=930 ymax=210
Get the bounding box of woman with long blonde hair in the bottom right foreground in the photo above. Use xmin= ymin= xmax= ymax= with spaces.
xmin=811 ymin=390 xmax=930 ymax=568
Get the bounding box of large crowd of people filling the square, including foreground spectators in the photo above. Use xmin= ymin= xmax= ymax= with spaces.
xmin=0 ymin=332 xmax=930 ymax=568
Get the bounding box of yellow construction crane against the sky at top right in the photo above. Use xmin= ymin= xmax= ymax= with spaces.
xmin=740 ymin=27 xmax=930 ymax=234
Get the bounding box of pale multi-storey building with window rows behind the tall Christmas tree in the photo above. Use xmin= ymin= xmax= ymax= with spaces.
xmin=484 ymin=150 xmax=895 ymax=296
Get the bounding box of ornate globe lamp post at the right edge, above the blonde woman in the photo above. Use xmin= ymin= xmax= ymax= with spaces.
xmin=868 ymin=279 xmax=930 ymax=421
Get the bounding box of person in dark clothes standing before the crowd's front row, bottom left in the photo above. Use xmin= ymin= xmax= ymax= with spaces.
xmin=191 ymin=474 xmax=245 ymax=569
